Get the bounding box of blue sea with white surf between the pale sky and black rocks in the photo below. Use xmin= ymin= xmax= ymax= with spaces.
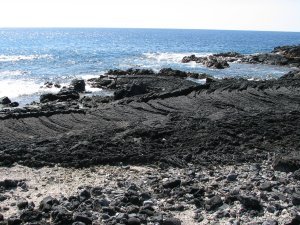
xmin=0 ymin=28 xmax=300 ymax=105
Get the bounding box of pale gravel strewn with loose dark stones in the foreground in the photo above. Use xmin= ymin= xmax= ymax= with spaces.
xmin=0 ymin=157 xmax=300 ymax=225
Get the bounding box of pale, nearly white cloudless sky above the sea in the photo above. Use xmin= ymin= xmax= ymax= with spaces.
xmin=0 ymin=0 xmax=300 ymax=31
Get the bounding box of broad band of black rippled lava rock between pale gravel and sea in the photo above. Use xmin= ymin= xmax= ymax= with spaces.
xmin=0 ymin=70 xmax=300 ymax=167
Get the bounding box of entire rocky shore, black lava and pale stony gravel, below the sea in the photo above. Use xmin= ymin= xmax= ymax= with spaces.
xmin=0 ymin=46 xmax=300 ymax=225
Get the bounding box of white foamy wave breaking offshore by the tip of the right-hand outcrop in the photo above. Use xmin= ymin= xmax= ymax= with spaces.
xmin=143 ymin=52 xmax=211 ymax=63
